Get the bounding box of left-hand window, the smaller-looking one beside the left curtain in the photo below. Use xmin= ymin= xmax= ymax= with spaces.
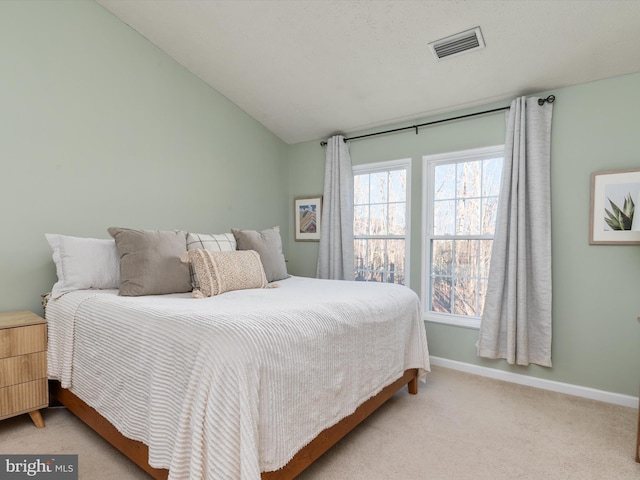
xmin=353 ymin=159 xmax=411 ymax=285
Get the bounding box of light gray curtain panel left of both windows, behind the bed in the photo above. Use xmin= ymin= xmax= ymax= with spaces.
xmin=317 ymin=135 xmax=354 ymax=280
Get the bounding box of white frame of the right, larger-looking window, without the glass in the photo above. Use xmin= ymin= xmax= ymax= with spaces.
xmin=421 ymin=145 xmax=504 ymax=329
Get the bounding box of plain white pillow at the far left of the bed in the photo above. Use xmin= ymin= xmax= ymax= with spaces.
xmin=45 ymin=233 xmax=120 ymax=298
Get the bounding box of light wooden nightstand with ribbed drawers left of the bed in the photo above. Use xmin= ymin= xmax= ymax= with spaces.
xmin=0 ymin=311 xmax=49 ymax=428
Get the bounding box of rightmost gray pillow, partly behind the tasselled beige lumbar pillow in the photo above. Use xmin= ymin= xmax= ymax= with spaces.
xmin=231 ymin=227 xmax=289 ymax=282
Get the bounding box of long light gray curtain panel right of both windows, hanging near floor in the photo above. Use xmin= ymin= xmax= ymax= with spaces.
xmin=478 ymin=97 xmax=553 ymax=367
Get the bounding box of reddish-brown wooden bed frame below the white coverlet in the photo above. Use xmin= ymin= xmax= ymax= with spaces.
xmin=50 ymin=369 xmax=418 ymax=480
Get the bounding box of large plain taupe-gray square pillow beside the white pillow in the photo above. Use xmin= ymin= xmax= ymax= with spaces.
xmin=107 ymin=227 xmax=191 ymax=297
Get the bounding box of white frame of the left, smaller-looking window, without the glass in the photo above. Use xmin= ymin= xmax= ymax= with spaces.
xmin=351 ymin=158 xmax=411 ymax=287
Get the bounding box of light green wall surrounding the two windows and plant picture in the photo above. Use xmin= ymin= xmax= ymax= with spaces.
xmin=288 ymin=74 xmax=640 ymax=396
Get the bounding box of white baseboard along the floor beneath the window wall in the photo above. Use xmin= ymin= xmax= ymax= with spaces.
xmin=430 ymin=356 xmax=638 ymax=408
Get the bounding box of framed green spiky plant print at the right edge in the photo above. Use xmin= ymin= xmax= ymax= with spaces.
xmin=589 ymin=168 xmax=640 ymax=245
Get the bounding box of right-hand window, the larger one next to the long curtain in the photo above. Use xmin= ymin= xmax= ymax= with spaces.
xmin=422 ymin=145 xmax=504 ymax=328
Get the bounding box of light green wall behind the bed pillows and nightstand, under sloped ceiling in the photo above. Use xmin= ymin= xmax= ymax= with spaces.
xmin=0 ymin=0 xmax=291 ymax=312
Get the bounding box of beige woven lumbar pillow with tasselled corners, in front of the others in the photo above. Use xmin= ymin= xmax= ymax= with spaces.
xmin=182 ymin=248 xmax=267 ymax=298
